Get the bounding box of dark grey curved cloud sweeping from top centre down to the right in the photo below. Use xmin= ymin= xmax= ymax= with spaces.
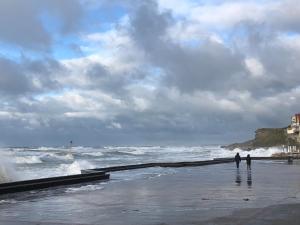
xmin=131 ymin=2 xmax=244 ymax=92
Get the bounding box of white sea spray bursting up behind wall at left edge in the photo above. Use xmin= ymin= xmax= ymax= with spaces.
xmin=0 ymin=154 xmax=18 ymax=183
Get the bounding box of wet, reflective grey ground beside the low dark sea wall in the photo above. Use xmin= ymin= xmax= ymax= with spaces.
xmin=0 ymin=161 xmax=300 ymax=225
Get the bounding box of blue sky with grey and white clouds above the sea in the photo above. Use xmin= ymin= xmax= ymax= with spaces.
xmin=0 ymin=0 xmax=300 ymax=146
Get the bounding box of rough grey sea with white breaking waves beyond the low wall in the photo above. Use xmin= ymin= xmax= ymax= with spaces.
xmin=0 ymin=145 xmax=282 ymax=183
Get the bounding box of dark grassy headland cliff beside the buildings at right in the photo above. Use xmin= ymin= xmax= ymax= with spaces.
xmin=222 ymin=128 xmax=300 ymax=150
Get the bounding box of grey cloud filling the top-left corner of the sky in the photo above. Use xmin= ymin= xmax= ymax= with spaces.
xmin=0 ymin=0 xmax=82 ymax=50
